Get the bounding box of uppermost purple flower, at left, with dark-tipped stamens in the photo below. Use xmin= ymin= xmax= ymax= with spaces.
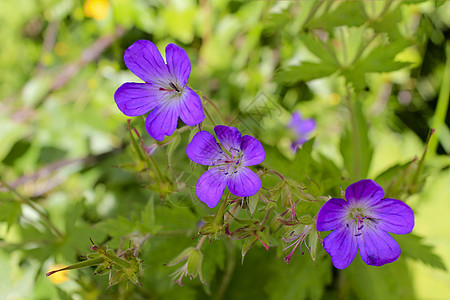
xmin=114 ymin=40 xmax=205 ymax=141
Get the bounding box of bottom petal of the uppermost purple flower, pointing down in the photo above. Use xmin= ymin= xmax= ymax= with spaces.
xmin=145 ymin=103 xmax=178 ymax=141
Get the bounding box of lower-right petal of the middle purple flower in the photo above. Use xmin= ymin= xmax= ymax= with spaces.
xmin=228 ymin=166 xmax=261 ymax=197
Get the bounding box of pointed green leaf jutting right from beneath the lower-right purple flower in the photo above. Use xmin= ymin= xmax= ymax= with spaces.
xmin=395 ymin=234 xmax=447 ymax=271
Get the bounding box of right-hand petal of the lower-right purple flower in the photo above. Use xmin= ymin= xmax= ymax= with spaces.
xmin=371 ymin=198 xmax=414 ymax=234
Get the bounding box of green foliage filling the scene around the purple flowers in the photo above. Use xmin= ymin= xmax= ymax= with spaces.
xmin=0 ymin=0 xmax=450 ymax=299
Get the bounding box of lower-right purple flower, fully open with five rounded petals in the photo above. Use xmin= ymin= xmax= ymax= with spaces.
xmin=317 ymin=179 xmax=414 ymax=269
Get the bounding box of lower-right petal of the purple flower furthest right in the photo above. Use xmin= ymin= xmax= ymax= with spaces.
xmin=357 ymin=226 xmax=401 ymax=266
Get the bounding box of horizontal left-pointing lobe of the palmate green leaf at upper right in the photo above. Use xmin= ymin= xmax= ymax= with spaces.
xmin=275 ymin=62 xmax=337 ymax=83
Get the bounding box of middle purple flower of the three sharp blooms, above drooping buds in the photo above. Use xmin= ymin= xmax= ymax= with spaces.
xmin=186 ymin=125 xmax=266 ymax=208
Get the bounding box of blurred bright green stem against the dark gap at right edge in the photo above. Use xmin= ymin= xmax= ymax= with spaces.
xmin=428 ymin=41 xmax=450 ymax=156
